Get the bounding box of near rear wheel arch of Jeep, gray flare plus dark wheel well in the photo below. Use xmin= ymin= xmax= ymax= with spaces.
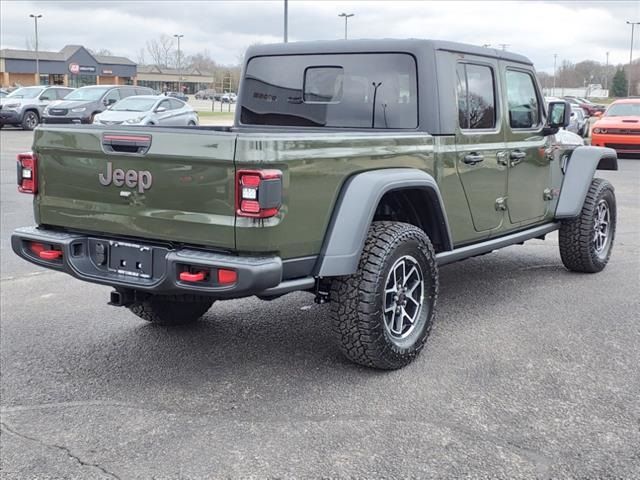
xmin=314 ymin=168 xmax=452 ymax=277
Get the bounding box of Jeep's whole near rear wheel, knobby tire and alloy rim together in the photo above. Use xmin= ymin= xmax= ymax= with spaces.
xmin=330 ymin=222 xmax=438 ymax=370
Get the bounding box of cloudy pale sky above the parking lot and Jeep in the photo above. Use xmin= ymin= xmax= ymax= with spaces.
xmin=0 ymin=0 xmax=640 ymax=72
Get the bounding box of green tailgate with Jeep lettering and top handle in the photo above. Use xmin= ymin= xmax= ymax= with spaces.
xmin=34 ymin=126 xmax=236 ymax=250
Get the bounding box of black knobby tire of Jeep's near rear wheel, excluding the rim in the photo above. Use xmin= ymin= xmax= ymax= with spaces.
xmin=330 ymin=222 xmax=438 ymax=370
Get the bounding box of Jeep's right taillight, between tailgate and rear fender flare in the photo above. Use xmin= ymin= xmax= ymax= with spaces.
xmin=236 ymin=170 xmax=282 ymax=218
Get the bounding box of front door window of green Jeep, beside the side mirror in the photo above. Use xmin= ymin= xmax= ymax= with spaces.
xmin=506 ymin=70 xmax=542 ymax=129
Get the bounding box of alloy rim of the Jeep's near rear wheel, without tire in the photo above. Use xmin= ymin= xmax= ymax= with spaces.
xmin=383 ymin=255 xmax=424 ymax=339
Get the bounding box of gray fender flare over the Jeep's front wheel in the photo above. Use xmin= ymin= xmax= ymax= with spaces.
xmin=555 ymin=146 xmax=618 ymax=219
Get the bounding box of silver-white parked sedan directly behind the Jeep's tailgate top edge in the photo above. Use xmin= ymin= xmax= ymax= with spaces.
xmin=93 ymin=95 xmax=199 ymax=126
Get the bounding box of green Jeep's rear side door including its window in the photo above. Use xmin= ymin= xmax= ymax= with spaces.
xmin=456 ymin=56 xmax=507 ymax=233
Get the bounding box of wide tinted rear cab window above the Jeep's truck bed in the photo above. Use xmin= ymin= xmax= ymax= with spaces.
xmin=240 ymin=53 xmax=418 ymax=129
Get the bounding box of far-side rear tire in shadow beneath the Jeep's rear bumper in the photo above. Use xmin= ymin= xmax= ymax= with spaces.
xmin=127 ymin=295 xmax=213 ymax=326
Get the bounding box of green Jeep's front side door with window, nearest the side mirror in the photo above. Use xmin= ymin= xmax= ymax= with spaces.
xmin=504 ymin=64 xmax=551 ymax=225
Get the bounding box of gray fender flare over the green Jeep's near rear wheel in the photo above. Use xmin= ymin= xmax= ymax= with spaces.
xmin=315 ymin=168 xmax=452 ymax=277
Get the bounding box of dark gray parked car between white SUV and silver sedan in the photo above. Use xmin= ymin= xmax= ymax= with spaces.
xmin=42 ymin=85 xmax=153 ymax=123
